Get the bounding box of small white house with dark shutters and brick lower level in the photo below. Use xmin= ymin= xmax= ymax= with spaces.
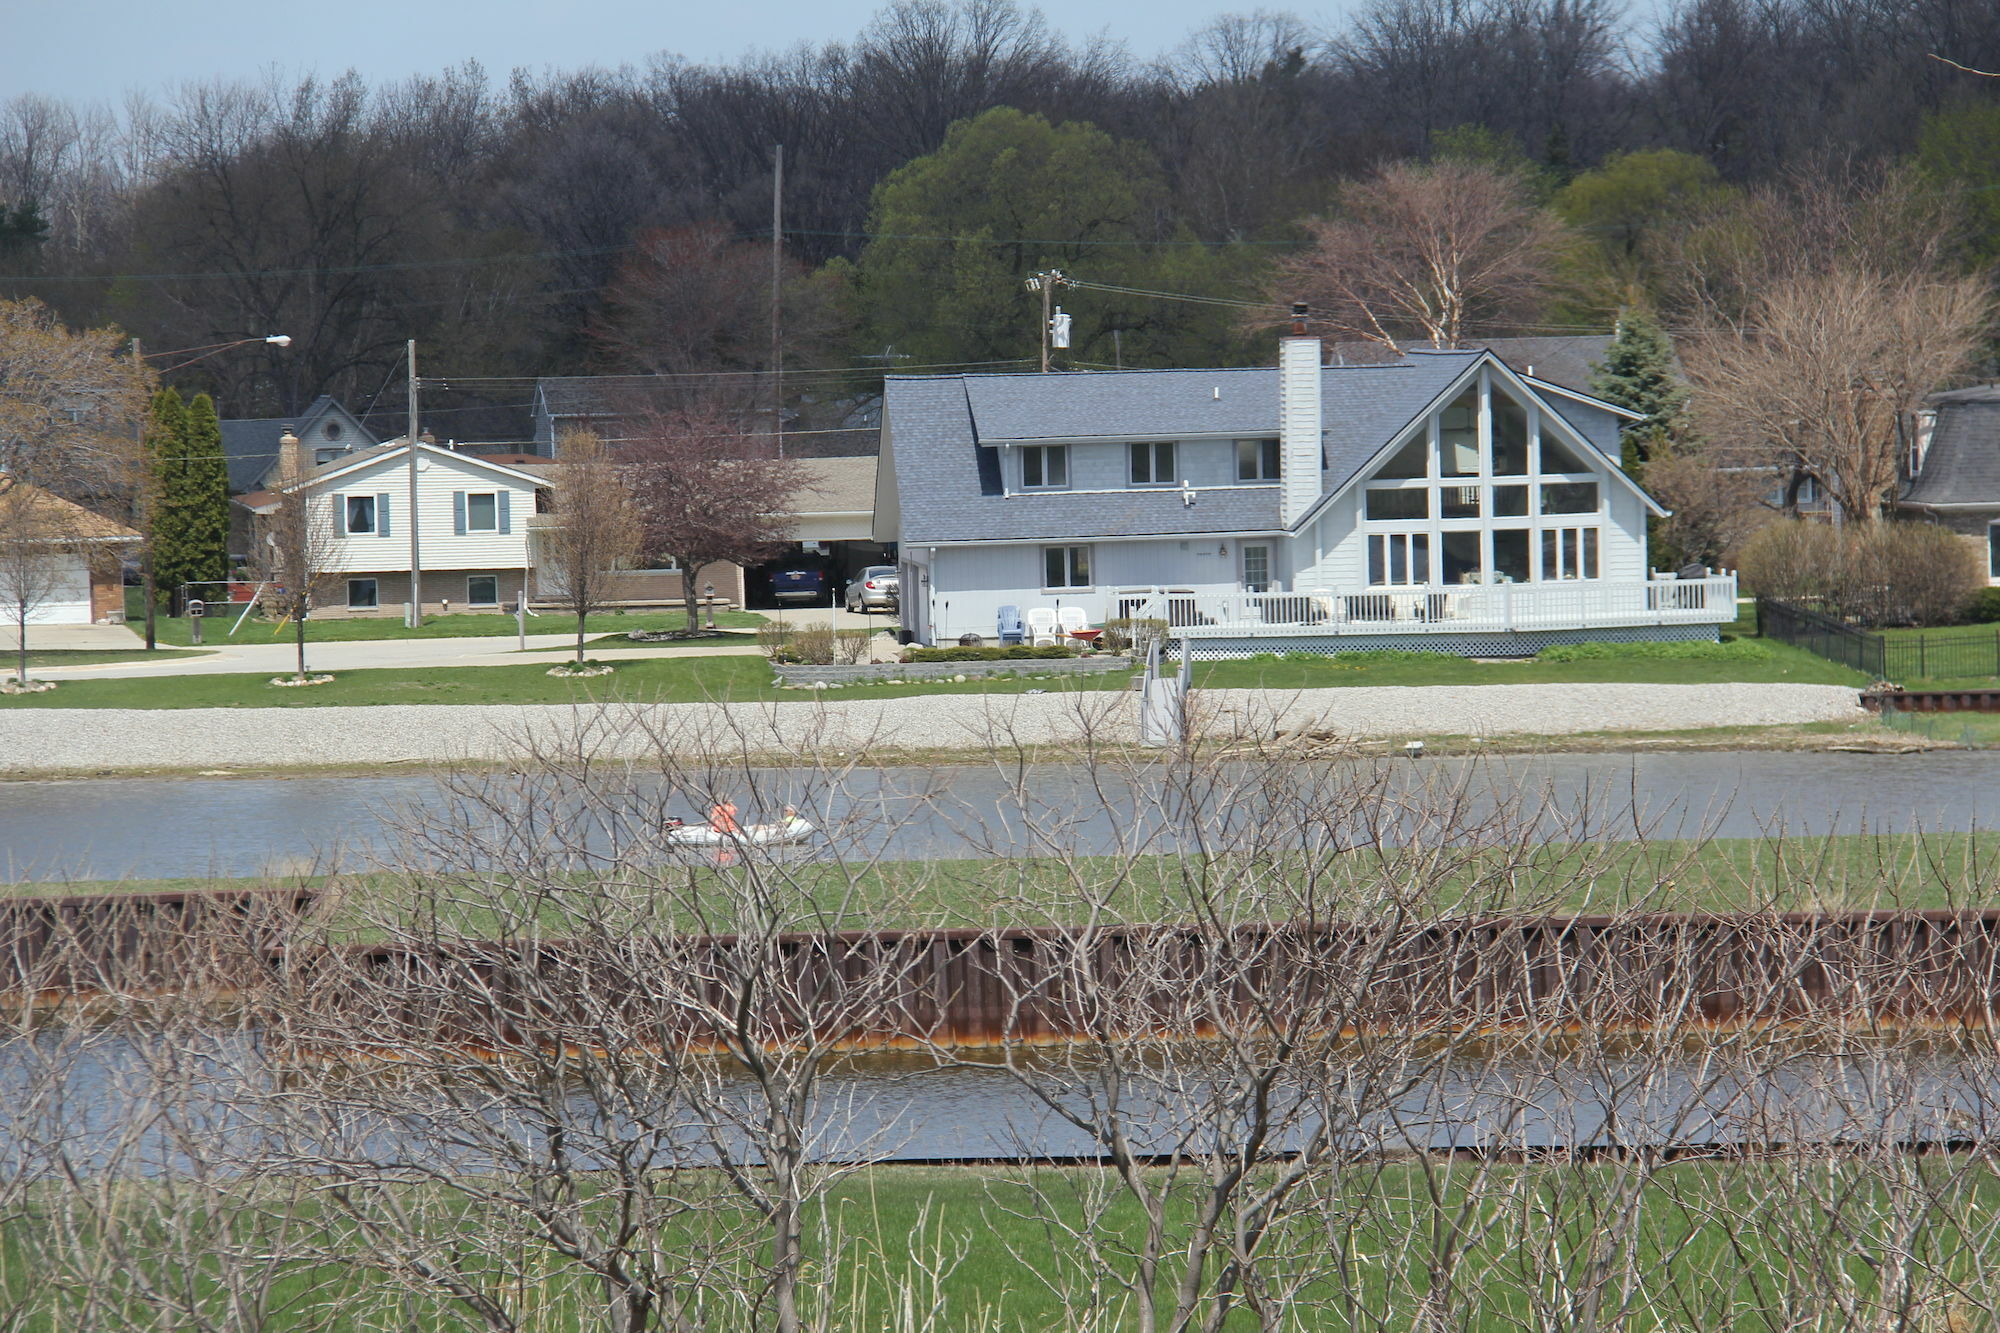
xmin=242 ymin=436 xmax=548 ymax=616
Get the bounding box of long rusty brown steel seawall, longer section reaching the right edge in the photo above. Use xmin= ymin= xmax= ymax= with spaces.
xmin=280 ymin=911 xmax=2000 ymax=1049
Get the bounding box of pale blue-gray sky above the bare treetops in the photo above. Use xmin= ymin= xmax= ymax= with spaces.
xmin=0 ymin=0 xmax=1346 ymax=102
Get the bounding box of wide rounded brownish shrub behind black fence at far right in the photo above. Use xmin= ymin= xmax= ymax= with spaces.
xmin=1740 ymin=520 xmax=1986 ymax=624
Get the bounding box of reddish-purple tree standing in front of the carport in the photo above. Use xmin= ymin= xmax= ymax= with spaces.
xmin=618 ymin=396 xmax=804 ymax=630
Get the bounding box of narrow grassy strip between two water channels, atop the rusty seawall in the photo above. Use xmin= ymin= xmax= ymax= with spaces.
xmin=19 ymin=833 xmax=2000 ymax=939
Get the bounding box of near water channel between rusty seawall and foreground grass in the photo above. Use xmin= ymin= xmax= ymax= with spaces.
xmin=19 ymin=1029 xmax=2000 ymax=1175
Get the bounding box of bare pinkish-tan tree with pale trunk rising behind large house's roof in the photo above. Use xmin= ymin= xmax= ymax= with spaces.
xmin=1266 ymin=162 xmax=1564 ymax=348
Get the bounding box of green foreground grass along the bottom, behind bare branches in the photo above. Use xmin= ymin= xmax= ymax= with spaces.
xmin=0 ymin=1159 xmax=2000 ymax=1333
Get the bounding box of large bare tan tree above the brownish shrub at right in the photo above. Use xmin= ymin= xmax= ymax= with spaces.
xmin=1682 ymin=264 xmax=1992 ymax=522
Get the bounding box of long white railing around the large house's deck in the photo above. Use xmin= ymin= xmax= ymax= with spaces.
xmin=1106 ymin=574 xmax=1736 ymax=638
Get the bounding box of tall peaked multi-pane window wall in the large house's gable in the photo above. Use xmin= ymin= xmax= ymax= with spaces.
xmin=1362 ymin=370 xmax=1606 ymax=586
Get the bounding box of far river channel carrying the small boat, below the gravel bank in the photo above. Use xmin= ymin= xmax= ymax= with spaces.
xmin=0 ymin=751 xmax=2000 ymax=883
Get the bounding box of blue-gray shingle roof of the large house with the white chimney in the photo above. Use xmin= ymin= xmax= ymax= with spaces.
xmin=884 ymin=352 xmax=1480 ymax=542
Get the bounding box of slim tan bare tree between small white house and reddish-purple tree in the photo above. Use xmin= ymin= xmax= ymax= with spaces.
xmin=540 ymin=430 xmax=640 ymax=667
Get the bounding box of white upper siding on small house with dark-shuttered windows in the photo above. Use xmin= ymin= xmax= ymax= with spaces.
xmin=314 ymin=452 xmax=534 ymax=572
